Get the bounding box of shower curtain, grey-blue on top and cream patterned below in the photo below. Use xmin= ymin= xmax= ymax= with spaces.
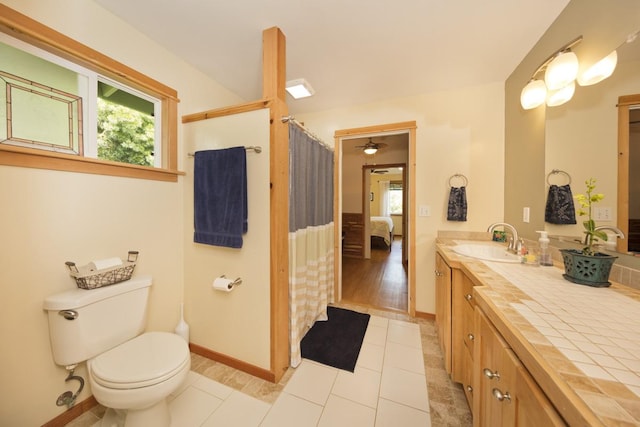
xmin=289 ymin=122 xmax=334 ymax=367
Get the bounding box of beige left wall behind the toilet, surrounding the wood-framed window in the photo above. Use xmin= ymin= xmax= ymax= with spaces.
xmin=0 ymin=0 xmax=241 ymax=426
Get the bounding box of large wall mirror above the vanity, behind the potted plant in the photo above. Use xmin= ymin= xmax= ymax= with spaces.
xmin=544 ymin=33 xmax=640 ymax=253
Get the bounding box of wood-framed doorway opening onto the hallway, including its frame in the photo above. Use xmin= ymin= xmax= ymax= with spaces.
xmin=334 ymin=122 xmax=415 ymax=315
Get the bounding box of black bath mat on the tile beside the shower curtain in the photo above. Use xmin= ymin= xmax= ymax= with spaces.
xmin=300 ymin=307 xmax=371 ymax=372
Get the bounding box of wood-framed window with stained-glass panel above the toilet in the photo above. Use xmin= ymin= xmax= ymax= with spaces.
xmin=0 ymin=4 xmax=182 ymax=181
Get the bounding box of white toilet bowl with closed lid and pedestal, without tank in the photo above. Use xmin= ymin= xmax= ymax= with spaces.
xmin=87 ymin=332 xmax=191 ymax=427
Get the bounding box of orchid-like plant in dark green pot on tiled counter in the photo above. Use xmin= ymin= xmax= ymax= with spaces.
xmin=560 ymin=178 xmax=618 ymax=287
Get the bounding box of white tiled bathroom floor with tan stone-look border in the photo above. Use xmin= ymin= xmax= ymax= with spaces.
xmin=67 ymin=304 xmax=471 ymax=427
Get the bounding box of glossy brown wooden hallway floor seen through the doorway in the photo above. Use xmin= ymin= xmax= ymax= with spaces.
xmin=342 ymin=237 xmax=408 ymax=313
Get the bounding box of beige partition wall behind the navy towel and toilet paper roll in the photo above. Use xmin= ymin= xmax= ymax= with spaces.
xmin=184 ymin=110 xmax=271 ymax=371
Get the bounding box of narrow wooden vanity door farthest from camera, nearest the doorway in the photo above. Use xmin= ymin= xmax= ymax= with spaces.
xmin=435 ymin=252 xmax=451 ymax=374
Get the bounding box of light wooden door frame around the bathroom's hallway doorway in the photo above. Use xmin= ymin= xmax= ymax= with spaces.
xmin=333 ymin=121 xmax=417 ymax=316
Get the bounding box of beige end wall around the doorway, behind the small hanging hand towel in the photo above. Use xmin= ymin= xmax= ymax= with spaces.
xmin=300 ymin=83 xmax=504 ymax=313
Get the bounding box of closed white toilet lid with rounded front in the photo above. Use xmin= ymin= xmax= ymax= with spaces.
xmin=90 ymin=332 xmax=190 ymax=389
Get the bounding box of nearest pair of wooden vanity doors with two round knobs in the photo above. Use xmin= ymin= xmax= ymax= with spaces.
xmin=473 ymin=307 xmax=566 ymax=427
